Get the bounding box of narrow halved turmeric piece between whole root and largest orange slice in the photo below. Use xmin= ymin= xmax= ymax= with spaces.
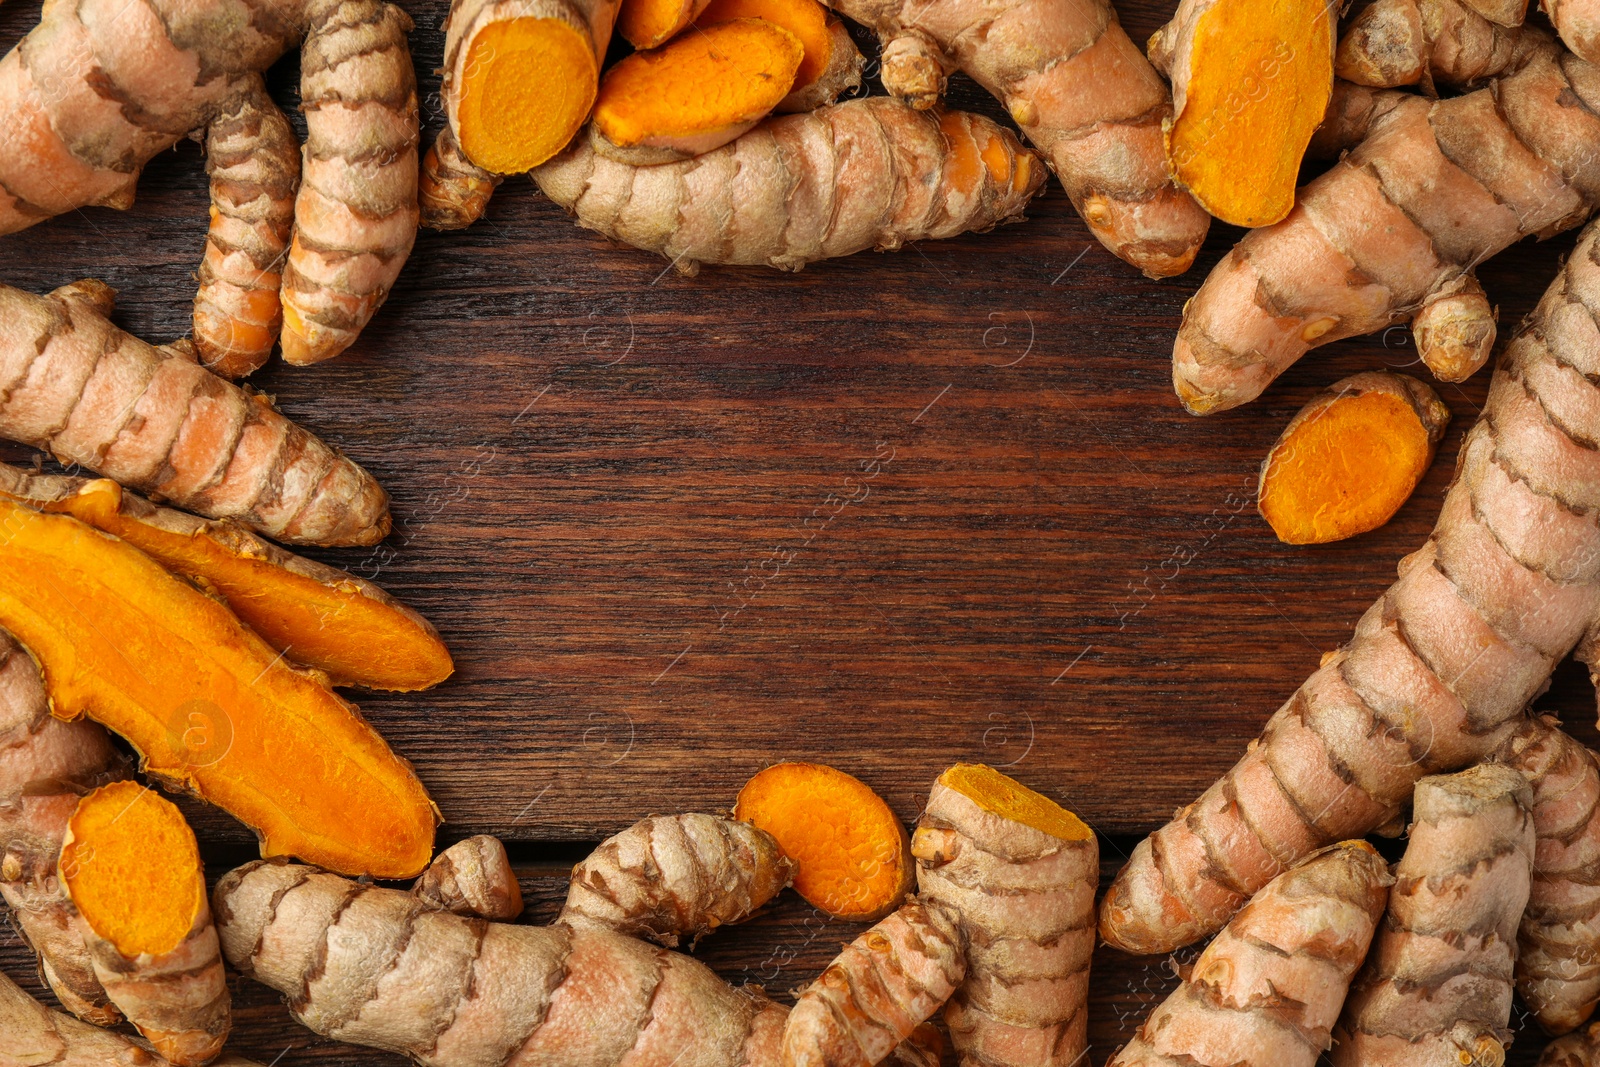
xmin=0 ymin=464 xmax=454 ymax=691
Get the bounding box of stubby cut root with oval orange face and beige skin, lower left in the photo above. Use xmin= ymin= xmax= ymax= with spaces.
xmin=61 ymin=782 xmax=232 ymax=1067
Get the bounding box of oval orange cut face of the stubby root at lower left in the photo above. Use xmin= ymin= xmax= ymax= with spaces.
xmin=61 ymin=782 xmax=205 ymax=958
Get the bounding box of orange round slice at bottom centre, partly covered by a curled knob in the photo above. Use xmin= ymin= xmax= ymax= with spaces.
xmin=733 ymin=763 xmax=914 ymax=921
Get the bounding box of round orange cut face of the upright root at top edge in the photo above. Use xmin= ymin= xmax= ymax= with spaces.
xmin=456 ymin=18 xmax=600 ymax=174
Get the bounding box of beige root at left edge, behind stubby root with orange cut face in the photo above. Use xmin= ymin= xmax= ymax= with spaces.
xmin=0 ymin=630 xmax=130 ymax=1030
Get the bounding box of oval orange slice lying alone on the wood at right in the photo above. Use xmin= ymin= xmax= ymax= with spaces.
xmin=1256 ymin=371 xmax=1450 ymax=544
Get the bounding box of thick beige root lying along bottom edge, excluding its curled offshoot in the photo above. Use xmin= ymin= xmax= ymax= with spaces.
xmin=214 ymin=862 xmax=800 ymax=1067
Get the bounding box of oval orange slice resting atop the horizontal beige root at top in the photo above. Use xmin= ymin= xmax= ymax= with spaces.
xmin=590 ymin=19 xmax=805 ymax=166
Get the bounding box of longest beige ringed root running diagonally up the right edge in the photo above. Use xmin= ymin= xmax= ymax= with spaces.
xmin=1101 ymin=220 xmax=1600 ymax=952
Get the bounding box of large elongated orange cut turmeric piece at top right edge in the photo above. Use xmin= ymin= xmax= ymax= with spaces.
xmin=1150 ymin=0 xmax=1336 ymax=227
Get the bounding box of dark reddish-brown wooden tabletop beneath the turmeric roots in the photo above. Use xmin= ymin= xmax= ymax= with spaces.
xmin=0 ymin=0 xmax=1594 ymax=1067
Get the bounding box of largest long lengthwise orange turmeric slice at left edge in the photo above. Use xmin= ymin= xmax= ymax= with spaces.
xmin=0 ymin=496 xmax=438 ymax=878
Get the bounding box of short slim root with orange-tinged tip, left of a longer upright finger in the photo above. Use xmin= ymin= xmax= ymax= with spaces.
xmin=194 ymin=75 xmax=301 ymax=378
